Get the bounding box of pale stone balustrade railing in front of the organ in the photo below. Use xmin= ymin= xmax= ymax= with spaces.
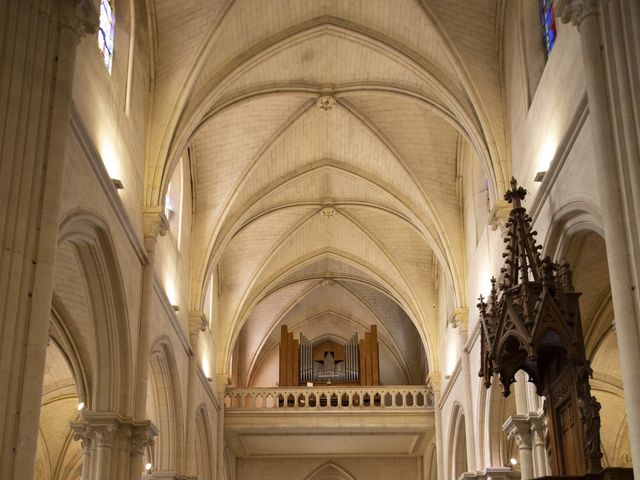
xmin=224 ymin=385 xmax=433 ymax=410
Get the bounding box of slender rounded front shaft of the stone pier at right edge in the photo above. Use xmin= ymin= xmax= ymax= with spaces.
xmin=556 ymin=0 xmax=640 ymax=472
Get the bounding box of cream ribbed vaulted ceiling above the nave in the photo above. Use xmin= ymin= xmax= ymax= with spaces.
xmin=147 ymin=0 xmax=506 ymax=384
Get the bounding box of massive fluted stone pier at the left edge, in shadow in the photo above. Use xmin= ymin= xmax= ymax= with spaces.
xmin=0 ymin=0 xmax=97 ymax=480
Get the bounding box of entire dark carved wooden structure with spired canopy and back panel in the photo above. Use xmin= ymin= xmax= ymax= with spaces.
xmin=478 ymin=178 xmax=602 ymax=475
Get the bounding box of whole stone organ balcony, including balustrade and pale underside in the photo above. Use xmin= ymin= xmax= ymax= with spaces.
xmin=224 ymin=385 xmax=434 ymax=458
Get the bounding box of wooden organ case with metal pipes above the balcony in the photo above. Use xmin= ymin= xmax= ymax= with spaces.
xmin=279 ymin=325 xmax=380 ymax=387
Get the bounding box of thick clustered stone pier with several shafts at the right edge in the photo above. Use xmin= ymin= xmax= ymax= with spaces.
xmin=557 ymin=0 xmax=640 ymax=472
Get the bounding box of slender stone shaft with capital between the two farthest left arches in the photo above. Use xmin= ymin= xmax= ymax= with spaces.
xmin=186 ymin=312 xmax=207 ymax=475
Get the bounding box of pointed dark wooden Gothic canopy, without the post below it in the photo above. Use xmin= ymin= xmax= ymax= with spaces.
xmin=478 ymin=179 xmax=585 ymax=396
